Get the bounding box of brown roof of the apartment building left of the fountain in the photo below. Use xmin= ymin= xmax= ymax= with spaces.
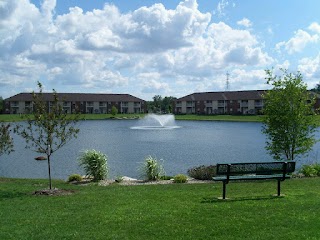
xmin=5 ymin=93 xmax=144 ymax=102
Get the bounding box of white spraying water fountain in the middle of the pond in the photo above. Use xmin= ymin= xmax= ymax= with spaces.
xmin=131 ymin=113 xmax=180 ymax=130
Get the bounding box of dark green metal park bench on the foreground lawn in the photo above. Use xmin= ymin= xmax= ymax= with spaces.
xmin=213 ymin=162 xmax=295 ymax=199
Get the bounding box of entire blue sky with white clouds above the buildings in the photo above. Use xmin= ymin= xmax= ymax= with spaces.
xmin=0 ymin=0 xmax=320 ymax=101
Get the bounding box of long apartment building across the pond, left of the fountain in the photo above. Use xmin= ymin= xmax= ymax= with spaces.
xmin=5 ymin=93 xmax=147 ymax=114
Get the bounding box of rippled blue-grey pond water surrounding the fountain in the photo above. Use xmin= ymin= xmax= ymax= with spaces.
xmin=0 ymin=120 xmax=320 ymax=179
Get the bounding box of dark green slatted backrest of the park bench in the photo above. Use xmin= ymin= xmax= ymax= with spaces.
xmin=217 ymin=162 xmax=296 ymax=175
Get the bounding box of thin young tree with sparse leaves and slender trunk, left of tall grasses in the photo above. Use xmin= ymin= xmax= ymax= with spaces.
xmin=15 ymin=82 xmax=79 ymax=190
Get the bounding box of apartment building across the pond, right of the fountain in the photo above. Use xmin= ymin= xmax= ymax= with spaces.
xmin=174 ymin=90 xmax=320 ymax=114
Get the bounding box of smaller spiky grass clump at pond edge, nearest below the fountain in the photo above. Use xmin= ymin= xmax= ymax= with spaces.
xmin=141 ymin=156 xmax=164 ymax=181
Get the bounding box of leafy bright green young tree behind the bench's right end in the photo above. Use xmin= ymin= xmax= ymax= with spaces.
xmin=262 ymin=69 xmax=317 ymax=160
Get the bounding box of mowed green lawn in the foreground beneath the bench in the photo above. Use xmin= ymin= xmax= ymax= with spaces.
xmin=0 ymin=178 xmax=320 ymax=240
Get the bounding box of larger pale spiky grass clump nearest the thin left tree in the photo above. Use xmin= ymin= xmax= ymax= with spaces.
xmin=79 ymin=149 xmax=108 ymax=181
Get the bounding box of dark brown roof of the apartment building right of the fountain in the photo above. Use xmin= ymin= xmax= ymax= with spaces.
xmin=177 ymin=90 xmax=265 ymax=101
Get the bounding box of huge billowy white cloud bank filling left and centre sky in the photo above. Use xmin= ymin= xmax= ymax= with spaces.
xmin=0 ymin=0 xmax=274 ymax=98
